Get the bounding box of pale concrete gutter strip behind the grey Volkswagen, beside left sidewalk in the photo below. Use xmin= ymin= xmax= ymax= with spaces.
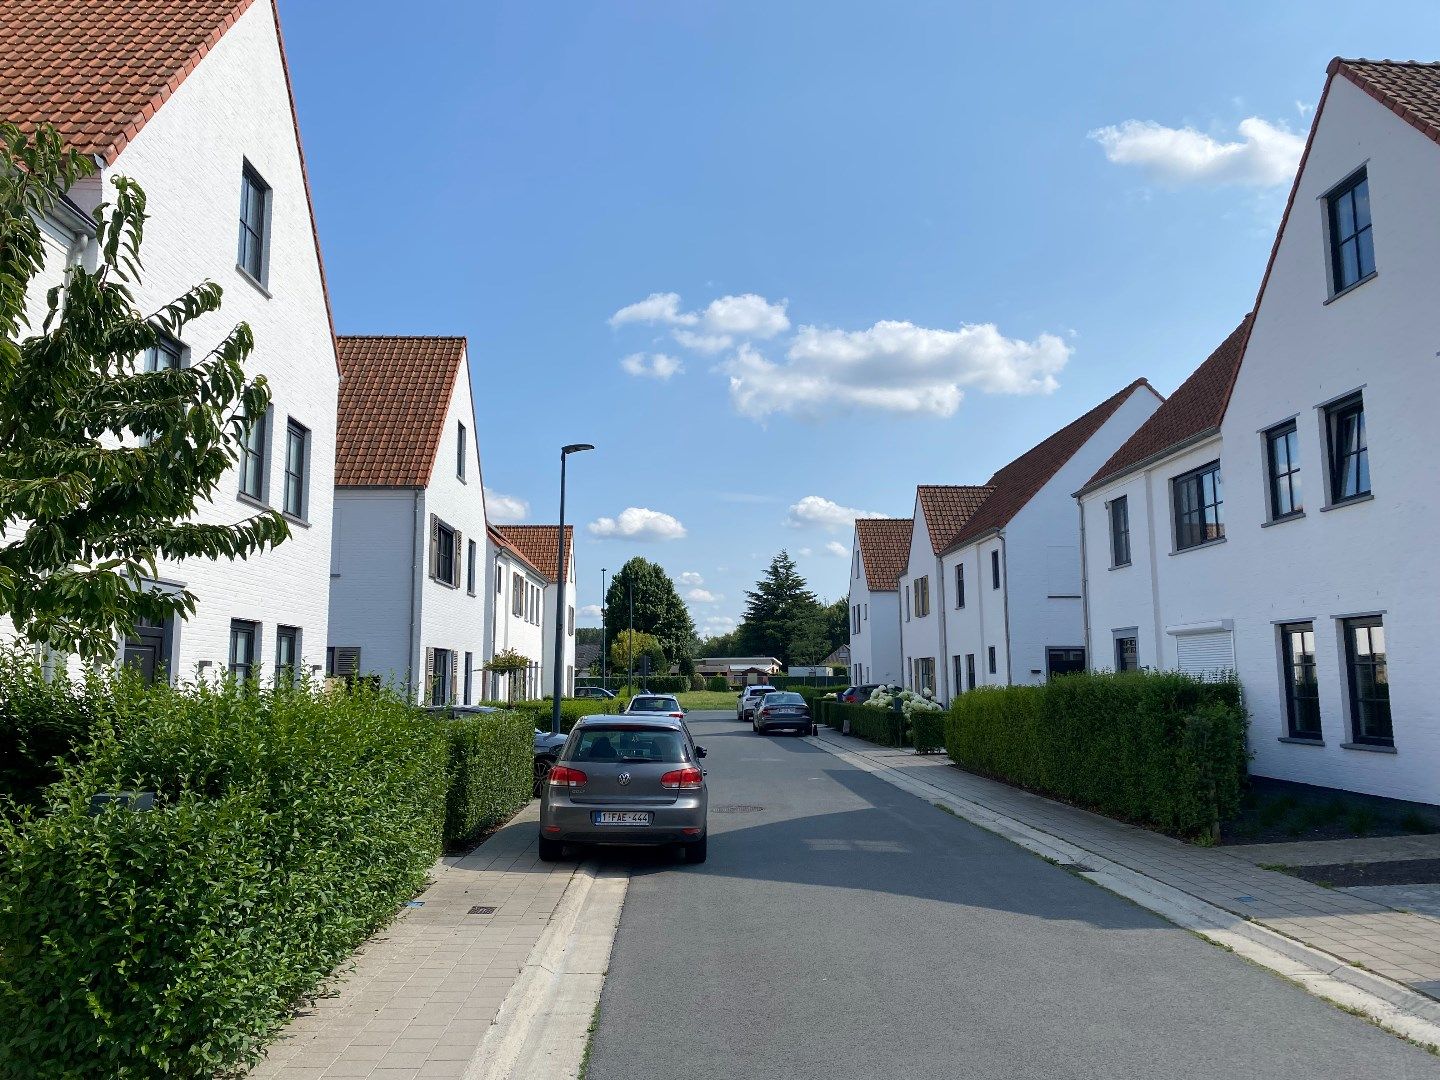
xmin=464 ymin=863 xmax=629 ymax=1080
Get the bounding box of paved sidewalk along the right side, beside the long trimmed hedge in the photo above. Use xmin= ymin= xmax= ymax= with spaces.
xmin=819 ymin=727 xmax=1440 ymax=998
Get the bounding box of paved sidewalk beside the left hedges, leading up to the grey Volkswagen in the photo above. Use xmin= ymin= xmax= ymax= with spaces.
xmin=249 ymin=804 xmax=576 ymax=1080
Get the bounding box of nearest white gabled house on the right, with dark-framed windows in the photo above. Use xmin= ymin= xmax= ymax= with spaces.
xmin=1081 ymin=60 xmax=1440 ymax=802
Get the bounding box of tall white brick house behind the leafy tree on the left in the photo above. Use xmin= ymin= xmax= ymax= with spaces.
xmin=0 ymin=0 xmax=338 ymax=678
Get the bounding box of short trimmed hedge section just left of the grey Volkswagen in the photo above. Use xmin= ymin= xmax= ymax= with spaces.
xmin=442 ymin=713 xmax=534 ymax=850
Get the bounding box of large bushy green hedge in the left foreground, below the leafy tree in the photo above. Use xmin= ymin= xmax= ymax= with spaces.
xmin=0 ymin=677 xmax=446 ymax=1079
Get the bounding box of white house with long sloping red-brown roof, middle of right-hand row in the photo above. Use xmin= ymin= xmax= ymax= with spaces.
xmin=900 ymin=379 xmax=1161 ymax=701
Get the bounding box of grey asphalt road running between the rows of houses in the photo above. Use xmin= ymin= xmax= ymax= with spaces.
xmin=588 ymin=713 xmax=1440 ymax=1080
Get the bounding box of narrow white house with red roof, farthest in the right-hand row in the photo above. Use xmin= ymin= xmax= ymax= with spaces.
xmin=850 ymin=517 xmax=914 ymax=685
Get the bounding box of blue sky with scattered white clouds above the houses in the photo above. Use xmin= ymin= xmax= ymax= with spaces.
xmin=281 ymin=0 xmax=1440 ymax=632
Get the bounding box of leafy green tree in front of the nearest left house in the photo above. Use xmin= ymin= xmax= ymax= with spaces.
xmin=0 ymin=131 xmax=289 ymax=660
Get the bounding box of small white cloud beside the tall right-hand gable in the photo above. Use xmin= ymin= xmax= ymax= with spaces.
xmin=1090 ymin=117 xmax=1305 ymax=187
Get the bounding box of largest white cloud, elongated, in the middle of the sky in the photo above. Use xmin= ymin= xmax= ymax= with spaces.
xmin=720 ymin=320 xmax=1071 ymax=420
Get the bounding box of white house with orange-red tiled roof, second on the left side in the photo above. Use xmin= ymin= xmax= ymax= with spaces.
xmin=328 ymin=337 xmax=488 ymax=704
